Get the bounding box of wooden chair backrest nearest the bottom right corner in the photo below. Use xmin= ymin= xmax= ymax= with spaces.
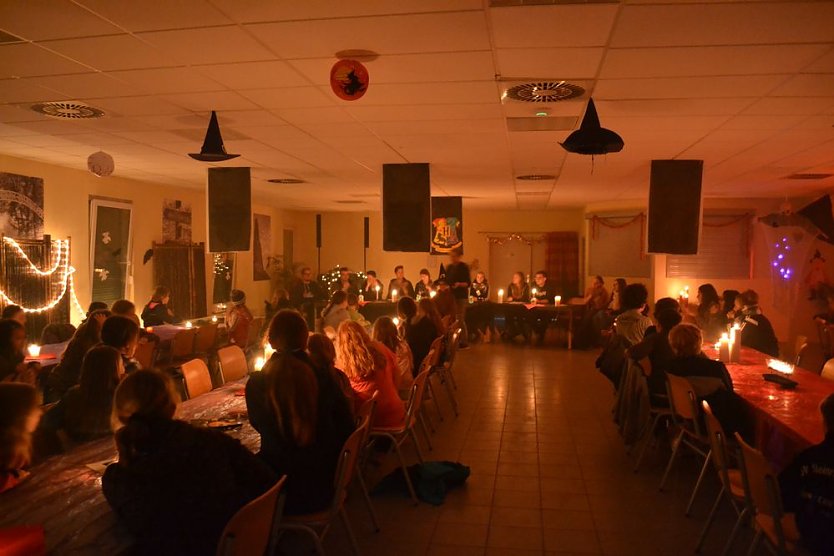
xmin=735 ymin=433 xmax=785 ymax=548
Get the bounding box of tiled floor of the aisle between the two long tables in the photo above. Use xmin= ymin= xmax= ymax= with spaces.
xmin=314 ymin=344 xmax=751 ymax=556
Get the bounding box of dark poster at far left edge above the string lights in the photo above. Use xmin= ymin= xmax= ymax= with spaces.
xmin=0 ymin=172 xmax=43 ymax=239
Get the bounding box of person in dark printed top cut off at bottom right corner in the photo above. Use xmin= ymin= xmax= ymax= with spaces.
xmin=779 ymin=394 xmax=834 ymax=554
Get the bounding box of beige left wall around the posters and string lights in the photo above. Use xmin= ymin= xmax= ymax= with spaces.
xmin=0 ymin=155 xmax=284 ymax=321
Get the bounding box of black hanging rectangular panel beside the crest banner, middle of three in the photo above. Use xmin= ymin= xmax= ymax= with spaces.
xmin=382 ymin=163 xmax=431 ymax=253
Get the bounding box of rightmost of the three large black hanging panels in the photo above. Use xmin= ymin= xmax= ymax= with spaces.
xmin=648 ymin=160 xmax=704 ymax=255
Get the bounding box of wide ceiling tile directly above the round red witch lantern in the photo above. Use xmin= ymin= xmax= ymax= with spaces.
xmin=245 ymin=12 xmax=490 ymax=59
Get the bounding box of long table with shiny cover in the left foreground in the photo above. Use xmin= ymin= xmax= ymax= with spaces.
xmin=0 ymin=378 xmax=254 ymax=555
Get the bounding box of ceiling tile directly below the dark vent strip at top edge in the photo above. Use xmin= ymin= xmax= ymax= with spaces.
xmin=489 ymin=4 xmax=617 ymax=48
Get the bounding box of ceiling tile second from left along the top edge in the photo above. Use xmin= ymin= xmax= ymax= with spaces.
xmin=75 ymin=0 xmax=229 ymax=31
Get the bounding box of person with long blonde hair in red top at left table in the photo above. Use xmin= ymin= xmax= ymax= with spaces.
xmin=336 ymin=321 xmax=405 ymax=427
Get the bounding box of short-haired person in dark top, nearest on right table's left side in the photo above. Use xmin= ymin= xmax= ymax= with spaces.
xmin=668 ymin=323 xmax=751 ymax=438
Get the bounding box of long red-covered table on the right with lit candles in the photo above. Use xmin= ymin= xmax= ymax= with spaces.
xmin=704 ymin=346 xmax=834 ymax=469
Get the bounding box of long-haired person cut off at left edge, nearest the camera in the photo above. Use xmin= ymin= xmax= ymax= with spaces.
xmin=0 ymin=382 xmax=41 ymax=493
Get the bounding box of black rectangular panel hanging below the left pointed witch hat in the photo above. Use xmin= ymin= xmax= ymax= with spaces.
xmin=208 ymin=168 xmax=252 ymax=253
